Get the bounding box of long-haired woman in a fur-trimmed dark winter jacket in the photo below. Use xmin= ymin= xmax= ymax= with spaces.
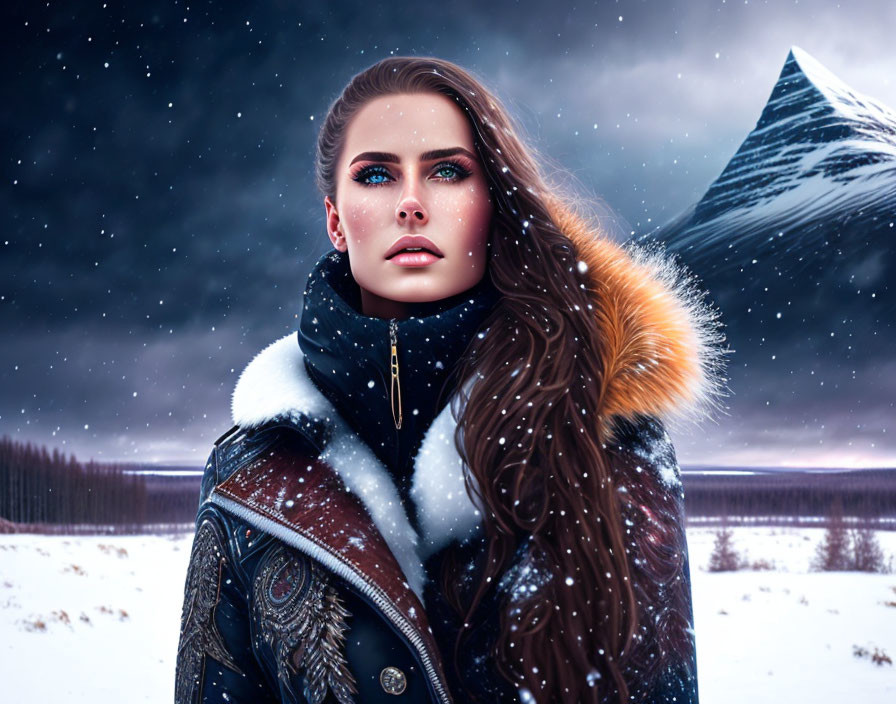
xmin=176 ymin=57 xmax=723 ymax=704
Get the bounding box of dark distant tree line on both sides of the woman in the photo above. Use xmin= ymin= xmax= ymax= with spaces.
xmin=0 ymin=428 xmax=896 ymax=531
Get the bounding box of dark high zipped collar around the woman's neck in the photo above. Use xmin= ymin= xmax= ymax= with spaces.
xmin=298 ymin=250 xmax=500 ymax=524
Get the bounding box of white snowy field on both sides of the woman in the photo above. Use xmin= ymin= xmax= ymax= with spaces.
xmin=0 ymin=528 xmax=896 ymax=704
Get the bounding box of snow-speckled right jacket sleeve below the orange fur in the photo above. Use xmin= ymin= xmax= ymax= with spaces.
xmin=613 ymin=416 xmax=699 ymax=704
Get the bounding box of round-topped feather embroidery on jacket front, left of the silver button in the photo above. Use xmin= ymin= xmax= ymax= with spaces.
xmin=254 ymin=544 xmax=357 ymax=704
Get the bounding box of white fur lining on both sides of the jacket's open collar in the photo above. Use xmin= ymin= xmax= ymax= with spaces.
xmin=232 ymin=333 xmax=481 ymax=601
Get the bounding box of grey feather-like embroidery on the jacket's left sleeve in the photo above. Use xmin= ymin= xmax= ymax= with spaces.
xmin=174 ymin=519 xmax=243 ymax=704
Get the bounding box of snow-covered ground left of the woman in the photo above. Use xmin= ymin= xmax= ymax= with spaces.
xmin=0 ymin=535 xmax=192 ymax=704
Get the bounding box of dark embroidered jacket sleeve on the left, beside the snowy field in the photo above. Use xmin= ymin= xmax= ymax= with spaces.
xmin=174 ymin=452 xmax=276 ymax=704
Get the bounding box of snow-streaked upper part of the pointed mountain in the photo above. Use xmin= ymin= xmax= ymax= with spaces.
xmin=649 ymin=46 xmax=896 ymax=278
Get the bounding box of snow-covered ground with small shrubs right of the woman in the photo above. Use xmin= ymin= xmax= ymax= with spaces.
xmin=688 ymin=528 xmax=896 ymax=704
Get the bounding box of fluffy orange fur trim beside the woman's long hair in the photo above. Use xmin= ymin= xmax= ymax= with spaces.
xmin=555 ymin=208 xmax=726 ymax=439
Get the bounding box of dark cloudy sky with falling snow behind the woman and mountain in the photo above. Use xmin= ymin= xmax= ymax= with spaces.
xmin=0 ymin=0 xmax=896 ymax=464
